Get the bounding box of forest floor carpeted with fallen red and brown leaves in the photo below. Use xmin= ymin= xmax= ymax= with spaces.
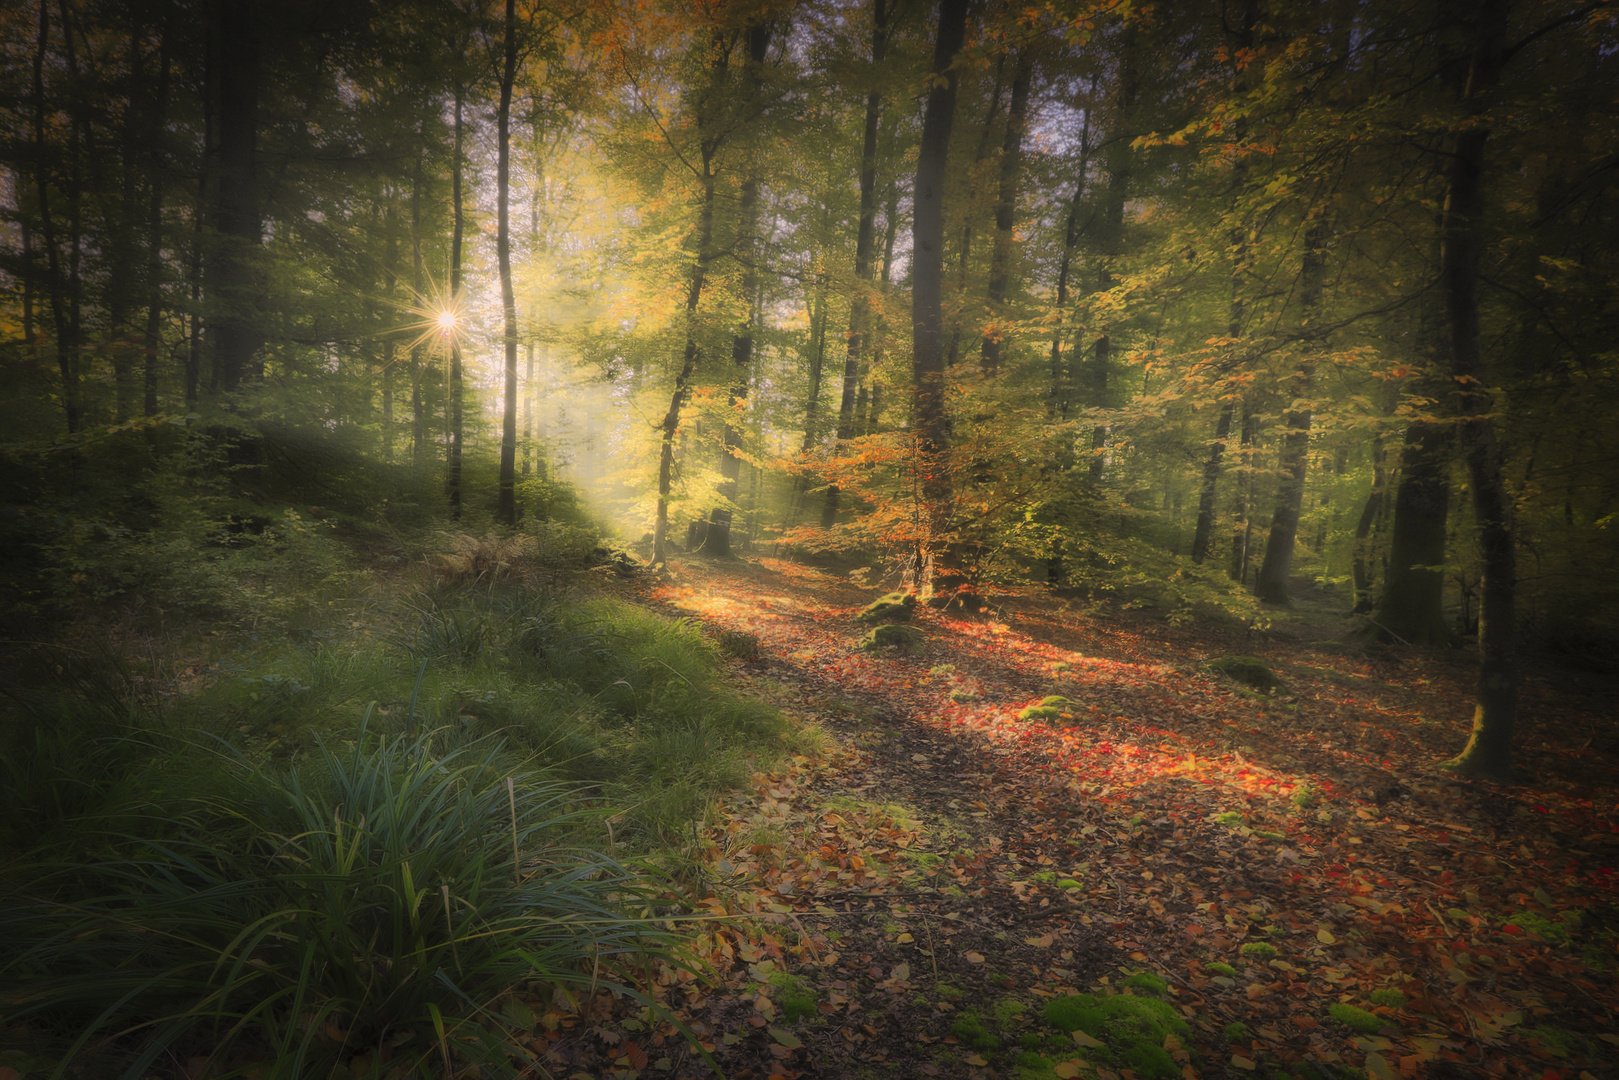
xmin=536 ymin=559 xmax=1619 ymax=1080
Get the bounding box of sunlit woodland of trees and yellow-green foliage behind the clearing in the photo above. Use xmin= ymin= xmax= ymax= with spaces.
xmin=0 ymin=0 xmax=1619 ymax=769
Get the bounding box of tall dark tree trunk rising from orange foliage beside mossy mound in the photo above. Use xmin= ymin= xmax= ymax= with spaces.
xmin=911 ymin=0 xmax=967 ymax=596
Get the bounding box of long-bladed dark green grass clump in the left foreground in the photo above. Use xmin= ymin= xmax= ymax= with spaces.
xmin=0 ymin=724 xmax=672 ymax=1080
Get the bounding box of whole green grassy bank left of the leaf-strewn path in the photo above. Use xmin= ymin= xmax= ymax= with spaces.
xmin=0 ymin=541 xmax=801 ymax=1077
